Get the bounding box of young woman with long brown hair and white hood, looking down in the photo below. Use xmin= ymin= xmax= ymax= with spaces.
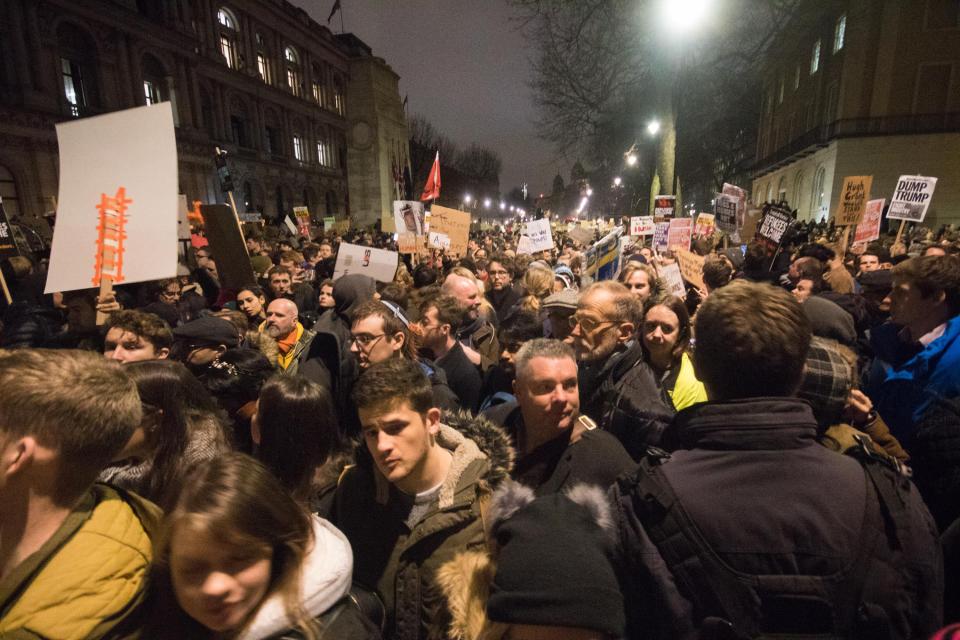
xmin=147 ymin=453 xmax=379 ymax=640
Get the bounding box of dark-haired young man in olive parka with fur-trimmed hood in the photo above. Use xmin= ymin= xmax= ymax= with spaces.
xmin=332 ymin=358 xmax=513 ymax=640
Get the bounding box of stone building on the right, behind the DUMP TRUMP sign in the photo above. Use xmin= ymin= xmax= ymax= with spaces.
xmin=752 ymin=0 xmax=960 ymax=226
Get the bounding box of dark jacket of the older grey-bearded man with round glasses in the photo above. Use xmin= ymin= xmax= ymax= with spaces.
xmin=579 ymin=341 xmax=674 ymax=460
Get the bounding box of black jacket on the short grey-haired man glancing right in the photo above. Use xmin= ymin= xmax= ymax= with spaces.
xmin=482 ymin=401 xmax=636 ymax=495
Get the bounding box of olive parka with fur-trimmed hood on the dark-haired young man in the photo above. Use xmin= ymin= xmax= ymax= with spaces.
xmin=333 ymin=414 xmax=513 ymax=640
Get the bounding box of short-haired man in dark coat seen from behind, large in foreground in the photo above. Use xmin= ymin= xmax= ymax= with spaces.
xmin=612 ymin=281 xmax=943 ymax=638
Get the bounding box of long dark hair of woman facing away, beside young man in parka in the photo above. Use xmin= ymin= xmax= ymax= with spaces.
xmin=252 ymin=375 xmax=340 ymax=504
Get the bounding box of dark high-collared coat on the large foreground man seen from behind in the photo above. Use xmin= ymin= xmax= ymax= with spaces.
xmin=611 ymin=398 xmax=943 ymax=638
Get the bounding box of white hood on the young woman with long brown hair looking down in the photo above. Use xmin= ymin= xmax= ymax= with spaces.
xmin=239 ymin=516 xmax=353 ymax=640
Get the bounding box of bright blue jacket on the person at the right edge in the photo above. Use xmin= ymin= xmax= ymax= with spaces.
xmin=865 ymin=316 xmax=960 ymax=449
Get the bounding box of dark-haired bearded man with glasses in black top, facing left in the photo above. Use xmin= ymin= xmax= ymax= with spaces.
xmin=420 ymin=294 xmax=482 ymax=411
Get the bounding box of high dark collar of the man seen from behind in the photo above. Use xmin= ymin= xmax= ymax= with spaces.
xmin=667 ymin=398 xmax=817 ymax=451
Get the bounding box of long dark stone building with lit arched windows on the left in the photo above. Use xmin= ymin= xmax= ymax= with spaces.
xmin=0 ymin=0 xmax=350 ymax=239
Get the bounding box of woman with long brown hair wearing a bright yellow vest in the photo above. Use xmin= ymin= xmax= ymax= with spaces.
xmin=640 ymin=296 xmax=707 ymax=411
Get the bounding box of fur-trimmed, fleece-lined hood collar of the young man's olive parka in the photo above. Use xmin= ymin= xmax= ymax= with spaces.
xmin=373 ymin=412 xmax=514 ymax=510
